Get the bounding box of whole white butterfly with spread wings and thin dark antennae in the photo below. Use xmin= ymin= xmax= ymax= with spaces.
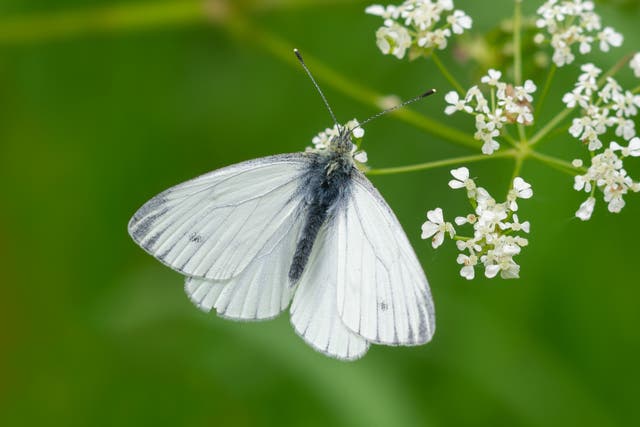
xmin=128 ymin=50 xmax=435 ymax=360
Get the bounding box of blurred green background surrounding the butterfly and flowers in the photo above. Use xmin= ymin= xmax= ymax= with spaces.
xmin=0 ymin=0 xmax=640 ymax=427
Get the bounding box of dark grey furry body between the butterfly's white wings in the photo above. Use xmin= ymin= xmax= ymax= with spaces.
xmin=289 ymin=151 xmax=356 ymax=285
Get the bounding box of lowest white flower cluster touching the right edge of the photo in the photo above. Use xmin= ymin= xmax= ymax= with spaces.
xmin=573 ymin=137 xmax=640 ymax=221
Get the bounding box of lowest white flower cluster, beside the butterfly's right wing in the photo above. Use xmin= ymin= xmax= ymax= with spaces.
xmin=422 ymin=167 xmax=533 ymax=280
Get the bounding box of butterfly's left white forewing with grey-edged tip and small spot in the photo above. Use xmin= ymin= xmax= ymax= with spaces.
xmin=129 ymin=154 xmax=308 ymax=280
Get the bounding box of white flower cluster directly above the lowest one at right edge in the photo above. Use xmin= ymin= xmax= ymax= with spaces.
xmin=562 ymin=64 xmax=640 ymax=151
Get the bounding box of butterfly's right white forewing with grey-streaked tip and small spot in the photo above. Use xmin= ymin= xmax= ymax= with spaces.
xmin=335 ymin=173 xmax=435 ymax=345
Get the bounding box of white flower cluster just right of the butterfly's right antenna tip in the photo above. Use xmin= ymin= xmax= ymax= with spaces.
xmin=444 ymin=70 xmax=537 ymax=154
